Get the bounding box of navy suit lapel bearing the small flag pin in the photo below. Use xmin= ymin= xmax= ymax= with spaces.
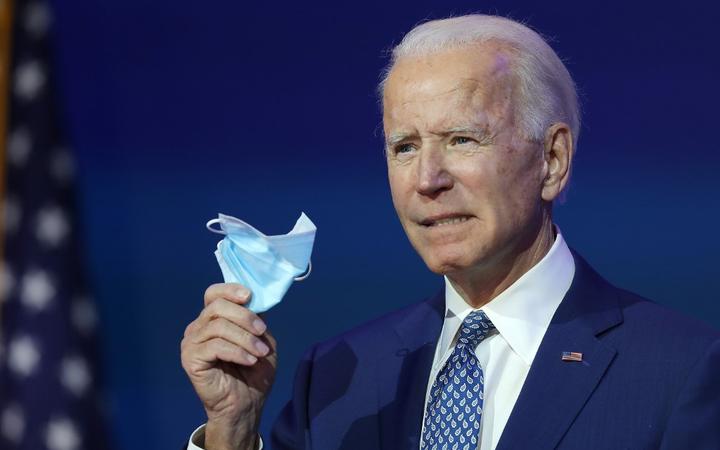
xmin=496 ymin=253 xmax=622 ymax=450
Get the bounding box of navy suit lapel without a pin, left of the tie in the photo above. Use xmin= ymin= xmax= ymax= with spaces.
xmin=378 ymin=291 xmax=445 ymax=450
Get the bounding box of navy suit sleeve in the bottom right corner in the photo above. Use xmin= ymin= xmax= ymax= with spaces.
xmin=660 ymin=339 xmax=720 ymax=450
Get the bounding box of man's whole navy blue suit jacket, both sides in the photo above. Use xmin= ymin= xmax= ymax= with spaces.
xmin=266 ymin=255 xmax=720 ymax=450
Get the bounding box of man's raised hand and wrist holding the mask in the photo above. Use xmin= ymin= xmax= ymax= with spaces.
xmin=180 ymin=283 xmax=277 ymax=450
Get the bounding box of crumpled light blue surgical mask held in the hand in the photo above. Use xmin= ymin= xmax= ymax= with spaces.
xmin=206 ymin=213 xmax=317 ymax=313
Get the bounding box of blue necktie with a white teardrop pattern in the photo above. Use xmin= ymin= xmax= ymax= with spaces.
xmin=420 ymin=311 xmax=495 ymax=450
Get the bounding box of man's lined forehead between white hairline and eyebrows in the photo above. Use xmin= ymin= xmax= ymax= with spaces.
xmin=383 ymin=43 xmax=516 ymax=125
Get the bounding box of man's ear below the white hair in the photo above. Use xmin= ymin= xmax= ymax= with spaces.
xmin=542 ymin=123 xmax=575 ymax=202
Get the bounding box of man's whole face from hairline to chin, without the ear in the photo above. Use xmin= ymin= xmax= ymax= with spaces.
xmin=383 ymin=44 xmax=545 ymax=275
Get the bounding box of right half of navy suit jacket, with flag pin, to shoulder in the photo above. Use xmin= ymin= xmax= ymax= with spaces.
xmin=497 ymin=254 xmax=720 ymax=450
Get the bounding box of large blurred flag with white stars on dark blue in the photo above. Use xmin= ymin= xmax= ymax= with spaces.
xmin=0 ymin=0 xmax=109 ymax=450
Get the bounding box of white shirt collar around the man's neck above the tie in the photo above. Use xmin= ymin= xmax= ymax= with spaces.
xmin=445 ymin=227 xmax=575 ymax=366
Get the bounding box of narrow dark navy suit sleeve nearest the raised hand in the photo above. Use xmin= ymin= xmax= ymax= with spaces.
xmin=271 ymin=348 xmax=315 ymax=450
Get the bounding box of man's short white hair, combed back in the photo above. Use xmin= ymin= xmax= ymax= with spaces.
xmin=379 ymin=14 xmax=580 ymax=144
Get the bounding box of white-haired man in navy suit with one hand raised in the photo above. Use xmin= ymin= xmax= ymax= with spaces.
xmin=182 ymin=15 xmax=720 ymax=450
